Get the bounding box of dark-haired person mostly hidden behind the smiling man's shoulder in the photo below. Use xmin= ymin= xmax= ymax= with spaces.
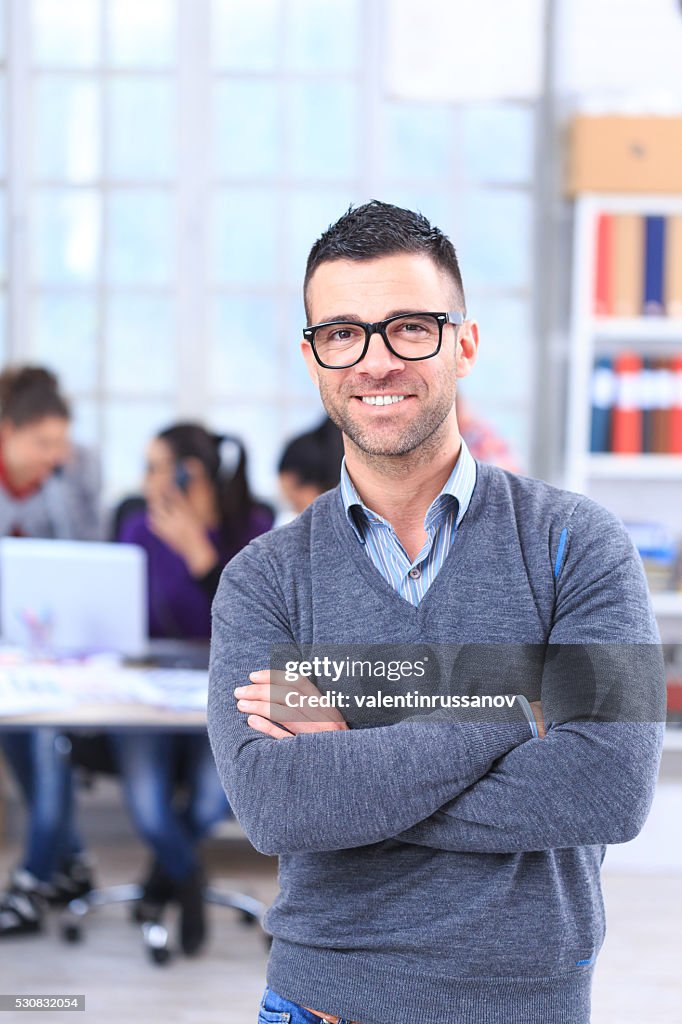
xmin=278 ymin=417 xmax=343 ymax=515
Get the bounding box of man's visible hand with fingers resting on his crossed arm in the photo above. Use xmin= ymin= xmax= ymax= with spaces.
xmin=235 ymin=669 xmax=348 ymax=739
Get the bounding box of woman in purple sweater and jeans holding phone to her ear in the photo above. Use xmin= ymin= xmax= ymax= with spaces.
xmin=113 ymin=423 xmax=272 ymax=955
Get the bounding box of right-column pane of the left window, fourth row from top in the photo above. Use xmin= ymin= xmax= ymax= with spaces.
xmin=104 ymin=295 xmax=178 ymax=395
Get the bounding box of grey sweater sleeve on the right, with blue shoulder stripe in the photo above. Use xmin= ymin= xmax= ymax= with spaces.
xmin=396 ymin=500 xmax=666 ymax=853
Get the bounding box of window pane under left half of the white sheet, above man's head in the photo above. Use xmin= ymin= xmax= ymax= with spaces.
xmin=384 ymin=103 xmax=454 ymax=181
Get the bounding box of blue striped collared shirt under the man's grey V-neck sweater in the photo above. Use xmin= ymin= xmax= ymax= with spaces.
xmin=341 ymin=440 xmax=476 ymax=605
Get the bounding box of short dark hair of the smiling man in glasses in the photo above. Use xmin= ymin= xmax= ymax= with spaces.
xmin=303 ymin=199 xmax=466 ymax=322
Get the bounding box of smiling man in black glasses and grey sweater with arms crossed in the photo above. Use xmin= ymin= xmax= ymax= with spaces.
xmin=209 ymin=202 xmax=664 ymax=1024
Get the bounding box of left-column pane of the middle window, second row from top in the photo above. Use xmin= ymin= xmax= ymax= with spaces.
xmin=213 ymin=81 xmax=282 ymax=178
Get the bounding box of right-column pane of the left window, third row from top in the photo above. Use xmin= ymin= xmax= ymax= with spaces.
xmin=106 ymin=189 xmax=175 ymax=285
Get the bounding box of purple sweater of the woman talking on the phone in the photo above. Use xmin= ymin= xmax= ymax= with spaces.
xmin=118 ymin=508 xmax=272 ymax=640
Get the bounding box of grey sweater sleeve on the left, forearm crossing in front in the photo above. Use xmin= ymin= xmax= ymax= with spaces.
xmin=208 ymin=543 xmax=530 ymax=854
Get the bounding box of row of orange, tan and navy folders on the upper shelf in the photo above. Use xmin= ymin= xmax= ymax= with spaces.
xmin=594 ymin=213 xmax=682 ymax=316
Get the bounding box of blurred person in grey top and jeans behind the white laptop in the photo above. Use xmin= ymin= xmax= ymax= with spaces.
xmin=0 ymin=367 xmax=100 ymax=936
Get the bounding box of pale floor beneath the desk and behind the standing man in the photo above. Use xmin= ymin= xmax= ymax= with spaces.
xmin=0 ymin=841 xmax=682 ymax=1024
